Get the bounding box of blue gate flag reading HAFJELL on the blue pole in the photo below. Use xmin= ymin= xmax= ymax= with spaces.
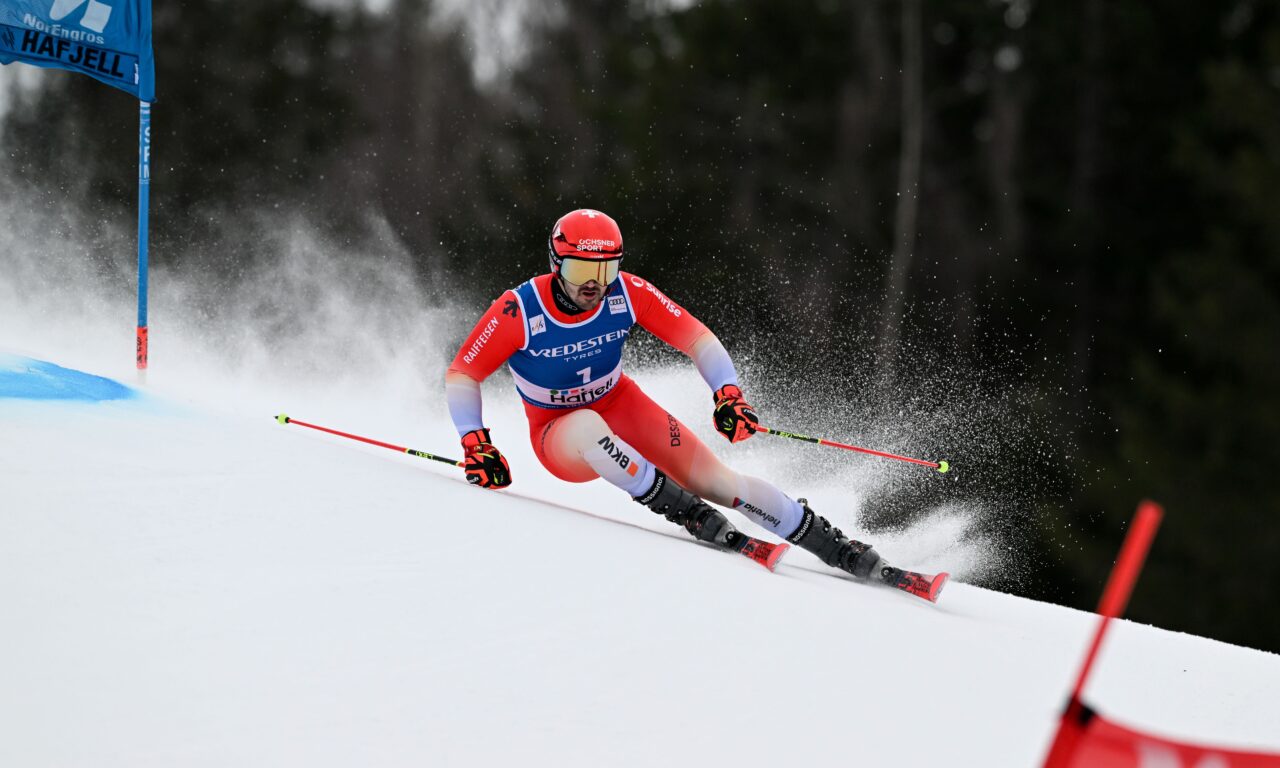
xmin=0 ymin=0 xmax=156 ymax=102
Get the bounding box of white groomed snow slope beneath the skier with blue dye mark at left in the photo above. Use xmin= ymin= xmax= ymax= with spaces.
xmin=0 ymin=355 xmax=1280 ymax=768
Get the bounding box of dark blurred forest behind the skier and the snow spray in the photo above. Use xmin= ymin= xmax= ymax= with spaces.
xmin=0 ymin=0 xmax=1280 ymax=650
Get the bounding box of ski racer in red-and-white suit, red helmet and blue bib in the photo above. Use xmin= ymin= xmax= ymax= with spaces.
xmin=444 ymin=210 xmax=901 ymax=581
